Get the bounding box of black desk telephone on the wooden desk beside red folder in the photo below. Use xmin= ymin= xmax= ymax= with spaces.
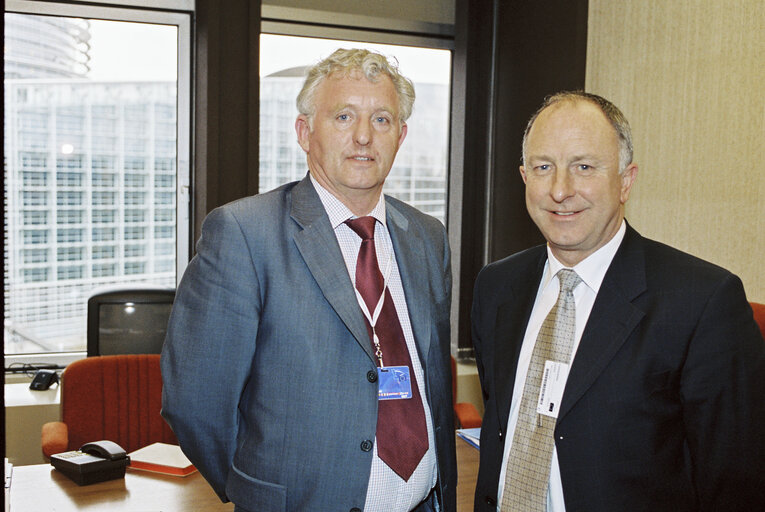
xmin=50 ymin=441 xmax=130 ymax=485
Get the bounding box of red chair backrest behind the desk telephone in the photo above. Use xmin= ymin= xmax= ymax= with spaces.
xmin=61 ymin=354 xmax=178 ymax=452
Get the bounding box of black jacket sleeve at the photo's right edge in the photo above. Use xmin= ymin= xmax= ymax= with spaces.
xmin=680 ymin=274 xmax=765 ymax=510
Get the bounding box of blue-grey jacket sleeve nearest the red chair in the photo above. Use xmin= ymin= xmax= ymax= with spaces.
xmin=161 ymin=208 xmax=260 ymax=501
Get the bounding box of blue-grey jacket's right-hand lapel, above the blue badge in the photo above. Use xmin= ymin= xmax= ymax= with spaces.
xmin=385 ymin=201 xmax=432 ymax=367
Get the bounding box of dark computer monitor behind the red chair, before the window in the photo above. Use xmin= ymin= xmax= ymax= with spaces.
xmin=88 ymin=288 xmax=175 ymax=357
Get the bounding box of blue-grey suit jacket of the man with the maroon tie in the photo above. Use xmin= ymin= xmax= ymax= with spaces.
xmin=162 ymin=177 xmax=456 ymax=512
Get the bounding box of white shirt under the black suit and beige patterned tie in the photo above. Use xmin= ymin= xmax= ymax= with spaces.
xmin=497 ymin=220 xmax=627 ymax=512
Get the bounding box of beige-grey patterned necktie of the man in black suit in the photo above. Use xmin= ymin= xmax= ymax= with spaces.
xmin=501 ymin=268 xmax=582 ymax=512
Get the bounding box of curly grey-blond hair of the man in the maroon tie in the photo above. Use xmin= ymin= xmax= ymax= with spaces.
xmin=297 ymin=48 xmax=414 ymax=123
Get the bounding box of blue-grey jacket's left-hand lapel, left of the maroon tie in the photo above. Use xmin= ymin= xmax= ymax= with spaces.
xmin=290 ymin=177 xmax=374 ymax=361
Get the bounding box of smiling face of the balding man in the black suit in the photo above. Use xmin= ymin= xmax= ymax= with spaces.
xmin=521 ymin=100 xmax=637 ymax=267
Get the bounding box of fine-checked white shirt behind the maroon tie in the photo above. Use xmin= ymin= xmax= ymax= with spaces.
xmin=311 ymin=176 xmax=438 ymax=512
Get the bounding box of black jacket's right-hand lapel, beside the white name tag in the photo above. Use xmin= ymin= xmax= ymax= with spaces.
xmin=558 ymin=225 xmax=646 ymax=421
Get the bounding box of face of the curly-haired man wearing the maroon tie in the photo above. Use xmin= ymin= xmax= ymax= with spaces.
xmin=295 ymin=73 xmax=406 ymax=215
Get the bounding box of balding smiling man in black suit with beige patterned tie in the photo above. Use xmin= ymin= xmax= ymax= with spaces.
xmin=472 ymin=92 xmax=765 ymax=512
